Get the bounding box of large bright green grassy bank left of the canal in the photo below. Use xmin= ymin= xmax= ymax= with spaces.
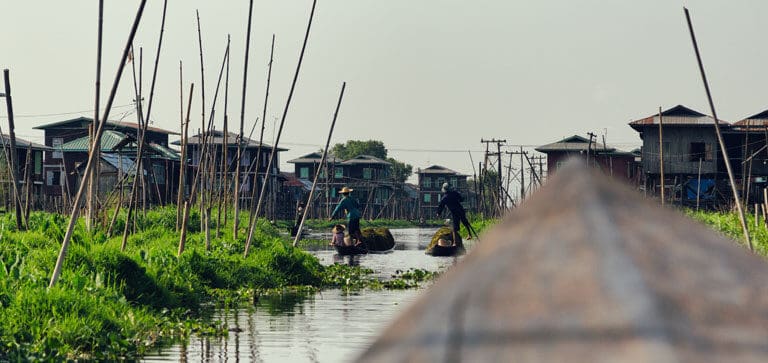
xmin=0 ymin=208 xmax=324 ymax=361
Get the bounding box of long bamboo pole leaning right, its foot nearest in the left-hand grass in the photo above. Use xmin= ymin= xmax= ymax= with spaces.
xmin=48 ymin=0 xmax=147 ymax=287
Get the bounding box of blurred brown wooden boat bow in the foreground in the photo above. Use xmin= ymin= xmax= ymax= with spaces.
xmin=359 ymin=159 xmax=768 ymax=362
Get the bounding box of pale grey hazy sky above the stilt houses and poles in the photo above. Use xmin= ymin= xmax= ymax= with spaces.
xmin=0 ymin=0 xmax=768 ymax=182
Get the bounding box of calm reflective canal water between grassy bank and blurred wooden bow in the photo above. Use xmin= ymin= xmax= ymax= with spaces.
xmin=144 ymin=228 xmax=456 ymax=362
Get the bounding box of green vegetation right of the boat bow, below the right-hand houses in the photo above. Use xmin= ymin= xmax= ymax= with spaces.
xmin=685 ymin=210 xmax=768 ymax=257
